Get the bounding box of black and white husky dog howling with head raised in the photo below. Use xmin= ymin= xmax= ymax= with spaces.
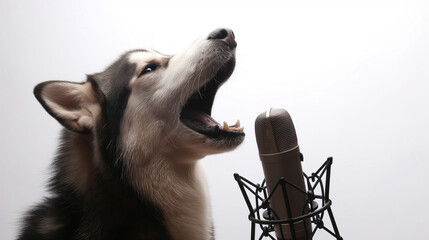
xmin=18 ymin=29 xmax=244 ymax=240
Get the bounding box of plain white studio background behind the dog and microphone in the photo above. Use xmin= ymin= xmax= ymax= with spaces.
xmin=0 ymin=0 xmax=429 ymax=240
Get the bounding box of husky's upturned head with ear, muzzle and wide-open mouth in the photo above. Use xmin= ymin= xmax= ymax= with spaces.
xmin=35 ymin=29 xmax=244 ymax=165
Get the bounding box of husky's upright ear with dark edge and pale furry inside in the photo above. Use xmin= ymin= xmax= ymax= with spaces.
xmin=34 ymin=78 xmax=104 ymax=133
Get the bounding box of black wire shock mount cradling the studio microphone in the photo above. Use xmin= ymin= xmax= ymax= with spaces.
xmin=234 ymin=157 xmax=343 ymax=240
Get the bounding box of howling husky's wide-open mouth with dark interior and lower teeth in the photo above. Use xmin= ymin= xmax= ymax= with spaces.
xmin=180 ymin=58 xmax=244 ymax=139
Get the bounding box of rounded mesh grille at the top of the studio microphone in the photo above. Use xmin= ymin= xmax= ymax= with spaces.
xmin=255 ymin=108 xmax=298 ymax=154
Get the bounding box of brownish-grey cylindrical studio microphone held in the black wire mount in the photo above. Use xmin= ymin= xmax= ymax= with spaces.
xmin=255 ymin=108 xmax=312 ymax=240
